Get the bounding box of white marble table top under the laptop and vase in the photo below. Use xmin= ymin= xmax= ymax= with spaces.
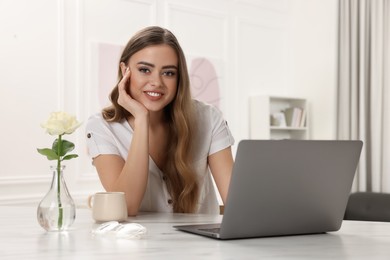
xmin=0 ymin=206 xmax=390 ymax=260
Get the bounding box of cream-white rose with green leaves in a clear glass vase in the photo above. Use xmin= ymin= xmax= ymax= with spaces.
xmin=37 ymin=112 xmax=81 ymax=231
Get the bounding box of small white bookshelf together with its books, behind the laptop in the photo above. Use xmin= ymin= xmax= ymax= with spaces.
xmin=249 ymin=96 xmax=309 ymax=140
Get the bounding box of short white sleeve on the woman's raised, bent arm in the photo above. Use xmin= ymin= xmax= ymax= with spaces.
xmin=86 ymin=115 xmax=120 ymax=158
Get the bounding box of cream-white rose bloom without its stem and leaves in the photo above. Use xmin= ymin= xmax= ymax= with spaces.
xmin=41 ymin=112 xmax=81 ymax=135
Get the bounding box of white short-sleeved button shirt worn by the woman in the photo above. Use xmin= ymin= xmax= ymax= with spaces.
xmin=86 ymin=100 xmax=234 ymax=214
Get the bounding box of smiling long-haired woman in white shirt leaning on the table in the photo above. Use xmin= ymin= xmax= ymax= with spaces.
xmin=87 ymin=26 xmax=234 ymax=216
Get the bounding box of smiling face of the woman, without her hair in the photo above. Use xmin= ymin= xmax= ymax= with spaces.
xmin=128 ymin=45 xmax=179 ymax=112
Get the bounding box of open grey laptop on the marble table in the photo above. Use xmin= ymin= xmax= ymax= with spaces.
xmin=174 ymin=140 xmax=363 ymax=239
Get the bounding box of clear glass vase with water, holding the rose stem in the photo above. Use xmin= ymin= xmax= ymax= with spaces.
xmin=37 ymin=166 xmax=76 ymax=231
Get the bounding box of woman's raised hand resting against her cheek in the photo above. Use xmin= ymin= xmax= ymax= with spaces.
xmin=118 ymin=67 xmax=148 ymax=118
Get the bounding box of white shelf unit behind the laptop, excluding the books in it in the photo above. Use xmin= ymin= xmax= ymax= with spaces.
xmin=249 ymin=96 xmax=309 ymax=140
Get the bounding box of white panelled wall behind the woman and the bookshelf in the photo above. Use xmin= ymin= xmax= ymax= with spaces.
xmin=0 ymin=0 xmax=337 ymax=204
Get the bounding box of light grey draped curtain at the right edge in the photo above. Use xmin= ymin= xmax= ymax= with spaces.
xmin=337 ymin=0 xmax=390 ymax=192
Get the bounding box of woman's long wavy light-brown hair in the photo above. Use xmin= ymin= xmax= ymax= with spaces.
xmin=102 ymin=26 xmax=199 ymax=213
